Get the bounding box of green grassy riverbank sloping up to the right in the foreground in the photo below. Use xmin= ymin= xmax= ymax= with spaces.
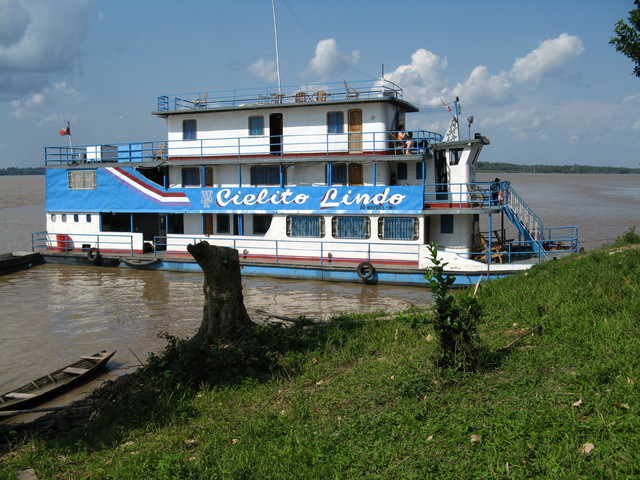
xmin=0 ymin=247 xmax=640 ymax=480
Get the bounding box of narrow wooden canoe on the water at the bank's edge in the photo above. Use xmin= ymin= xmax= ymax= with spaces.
xmin=0 ymin=350 xmax=116 ymax=411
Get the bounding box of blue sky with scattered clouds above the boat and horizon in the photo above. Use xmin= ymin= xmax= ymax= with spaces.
xmin=0 ymin=0 xmax=640 ymax=168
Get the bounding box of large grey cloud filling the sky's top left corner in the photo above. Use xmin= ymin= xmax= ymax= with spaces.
xmin=0 ymin=0 xmax=93 ymax=100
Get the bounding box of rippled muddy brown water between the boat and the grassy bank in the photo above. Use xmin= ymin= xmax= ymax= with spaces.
xmin=0 ymin=264 xmax=431 ymax=391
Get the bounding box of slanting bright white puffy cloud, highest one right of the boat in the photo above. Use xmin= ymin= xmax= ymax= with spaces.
xmin=511 ymin=33 xmax=585 ymax=87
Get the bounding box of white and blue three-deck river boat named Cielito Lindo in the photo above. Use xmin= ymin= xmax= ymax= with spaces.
xmin=33 ymin=79 xmax=578 ymax=285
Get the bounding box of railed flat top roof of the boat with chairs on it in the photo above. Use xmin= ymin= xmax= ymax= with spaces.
xmin=152 ymin=79 xmax=419 ymax=117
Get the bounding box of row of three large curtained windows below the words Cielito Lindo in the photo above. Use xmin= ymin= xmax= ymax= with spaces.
xmin=287 ymin=215 xmax=419 ymax=240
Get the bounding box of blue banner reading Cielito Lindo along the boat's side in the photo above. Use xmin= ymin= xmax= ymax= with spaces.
xmin=46 ymin=166 xmax=423 ymax=214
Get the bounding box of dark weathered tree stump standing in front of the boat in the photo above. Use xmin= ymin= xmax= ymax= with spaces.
xmin=187 ymin=241 xmax=254 ymax=344
